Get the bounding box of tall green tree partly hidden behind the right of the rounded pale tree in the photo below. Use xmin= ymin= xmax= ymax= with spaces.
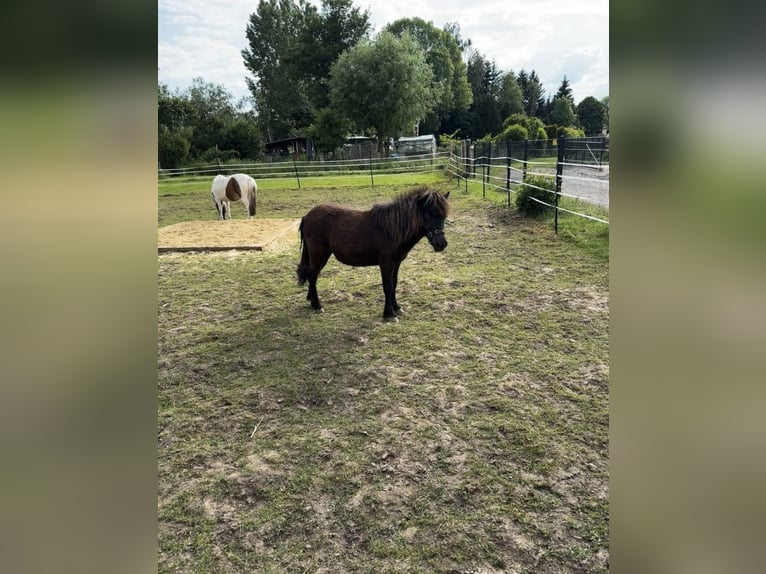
xmin=384 ymin=18 xmax=473 ymax=131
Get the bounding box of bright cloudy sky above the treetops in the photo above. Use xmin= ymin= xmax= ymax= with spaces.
xmin=157 ymin=0 xmax=609 ymax=107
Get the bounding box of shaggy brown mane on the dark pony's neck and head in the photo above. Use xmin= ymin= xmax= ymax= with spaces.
xmin=370 ymin=187 xmax=449 ymax=242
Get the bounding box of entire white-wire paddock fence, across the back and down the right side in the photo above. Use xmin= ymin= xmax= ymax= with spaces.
xmin=158 ymin=138 xmax=609 ymax=232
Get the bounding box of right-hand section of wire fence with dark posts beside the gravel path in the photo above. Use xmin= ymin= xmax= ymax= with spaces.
xmin=445 ymin=137 xmax=609 ymax=232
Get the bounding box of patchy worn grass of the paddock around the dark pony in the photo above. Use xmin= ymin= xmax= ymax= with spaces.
xmin=158 ymin=176 xmax=609 ymax=573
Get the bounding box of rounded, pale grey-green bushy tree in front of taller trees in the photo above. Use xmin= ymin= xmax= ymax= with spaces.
xmin=330 ymin=32 xmax=433 ymax=151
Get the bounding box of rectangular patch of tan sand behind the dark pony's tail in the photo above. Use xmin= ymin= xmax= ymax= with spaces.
xmin=157 ymin=219 xmax=300 ymax=253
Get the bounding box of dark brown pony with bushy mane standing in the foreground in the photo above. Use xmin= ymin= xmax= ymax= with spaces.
xmin=297 ymin=187 xmax=449 ymax=319
